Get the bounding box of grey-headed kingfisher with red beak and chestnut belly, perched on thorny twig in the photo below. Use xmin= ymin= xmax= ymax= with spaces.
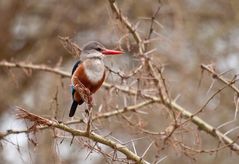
xmin=69 ymin=41 xmax=124 ymax=117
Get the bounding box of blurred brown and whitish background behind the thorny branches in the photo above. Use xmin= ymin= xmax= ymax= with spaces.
xmin=0 ymin=0 xmax=239 ymax=164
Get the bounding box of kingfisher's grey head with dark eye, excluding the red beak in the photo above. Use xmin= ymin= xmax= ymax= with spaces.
xmin=80 ymin=41 xmax=106 ymax=61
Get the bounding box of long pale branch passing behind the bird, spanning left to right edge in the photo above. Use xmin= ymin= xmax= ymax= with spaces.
xmin=0 ymin=61 xmax=239 ymax=154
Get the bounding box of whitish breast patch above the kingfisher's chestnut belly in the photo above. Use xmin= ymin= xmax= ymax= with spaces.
xmin=83 ymin=58 xmax=105 ymax=83
